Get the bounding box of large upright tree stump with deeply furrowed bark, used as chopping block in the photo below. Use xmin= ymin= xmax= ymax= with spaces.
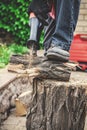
xmin=26 ymin=72 xmax=87 ymax=130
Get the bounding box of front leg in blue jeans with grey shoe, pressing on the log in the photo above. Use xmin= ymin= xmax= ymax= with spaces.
xmin=47 ymin=0 xmax=80 ymax=60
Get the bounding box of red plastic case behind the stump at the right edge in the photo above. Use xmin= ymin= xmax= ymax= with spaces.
xmin=70 ymin=34 xmax=87 ymax=70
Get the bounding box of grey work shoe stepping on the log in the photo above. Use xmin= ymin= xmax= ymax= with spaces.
xmin=46 ymin=46 xmax=69 ymax=61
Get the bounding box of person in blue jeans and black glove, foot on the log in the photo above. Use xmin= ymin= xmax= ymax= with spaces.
xmin=29 ymin=0 xmax=81 ymax=61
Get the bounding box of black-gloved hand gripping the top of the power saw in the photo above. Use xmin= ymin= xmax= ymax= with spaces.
xmin=28 ymin=0 xmax=50 ymax=25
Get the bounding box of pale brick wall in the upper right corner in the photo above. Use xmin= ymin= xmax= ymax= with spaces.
xmin=75 ymin=0 xmax=87 ymax=34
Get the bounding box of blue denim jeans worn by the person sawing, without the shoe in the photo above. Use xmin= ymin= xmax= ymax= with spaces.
xmin=44 ymin=0 xmax=81 ymax=51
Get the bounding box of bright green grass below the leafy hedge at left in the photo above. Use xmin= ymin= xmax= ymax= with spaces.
xmin=0 ymin=44 xmax=29 ymax=68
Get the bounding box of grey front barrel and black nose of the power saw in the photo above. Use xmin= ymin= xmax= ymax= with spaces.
xmin=27 ymin=17 xmax=40 ymax=56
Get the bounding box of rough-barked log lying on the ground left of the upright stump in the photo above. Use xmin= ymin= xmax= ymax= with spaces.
xmin=0 ymin=76 xmax=32 ymax=123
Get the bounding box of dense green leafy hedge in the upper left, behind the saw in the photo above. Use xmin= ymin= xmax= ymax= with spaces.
xmin=0 ymin=0 xmax=30 ymax=45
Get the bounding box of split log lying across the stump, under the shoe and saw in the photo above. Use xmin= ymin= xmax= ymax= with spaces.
xmin=8 ymin=53 xmax=78 ymax=81
